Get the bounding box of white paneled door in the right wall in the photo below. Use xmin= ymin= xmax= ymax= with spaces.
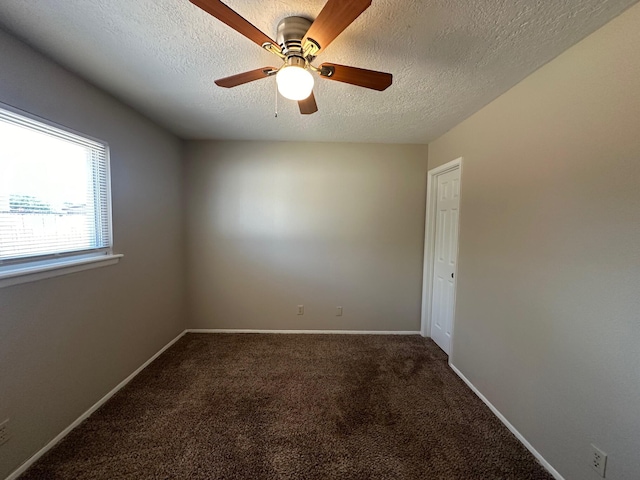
xmin=431 ymin=168 xmax=460 ymax=355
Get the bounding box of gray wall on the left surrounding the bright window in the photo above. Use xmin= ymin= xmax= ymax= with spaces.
xmin=0 ymin=32 xmax=185 ymax=478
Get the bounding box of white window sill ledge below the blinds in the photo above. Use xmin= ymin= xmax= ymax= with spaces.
xmin=0 ymin=254 xmax=124 ymax=288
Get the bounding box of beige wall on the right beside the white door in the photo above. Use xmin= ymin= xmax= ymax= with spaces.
xmin=429 ymin=5 xmax=640 ymax=480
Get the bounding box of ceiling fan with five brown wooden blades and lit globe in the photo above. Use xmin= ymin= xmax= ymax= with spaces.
xmin=189 ymin=0 xmax=393 ymax=115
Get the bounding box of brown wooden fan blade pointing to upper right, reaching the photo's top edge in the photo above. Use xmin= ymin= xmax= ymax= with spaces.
xmin=302 ymin=0 xmax=371 ymax=56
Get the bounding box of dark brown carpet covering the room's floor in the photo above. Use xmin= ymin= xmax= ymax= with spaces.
xmin=21 ymin=334 xmax=552 ymax=480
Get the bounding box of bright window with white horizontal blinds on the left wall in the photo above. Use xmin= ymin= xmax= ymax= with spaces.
xmin=0 ymin=104 xmax=120 ymax=286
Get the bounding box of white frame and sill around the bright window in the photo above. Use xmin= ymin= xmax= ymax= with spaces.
xmin=0 ymin=102 xmax=123 ymax=288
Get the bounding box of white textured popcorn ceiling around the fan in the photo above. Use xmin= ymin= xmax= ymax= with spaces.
xmin=0 ymin=0 xmax=637 ymax=143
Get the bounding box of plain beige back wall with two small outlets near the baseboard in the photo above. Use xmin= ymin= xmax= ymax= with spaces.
xmin=186 ymin=142 xmax=427 ymax=331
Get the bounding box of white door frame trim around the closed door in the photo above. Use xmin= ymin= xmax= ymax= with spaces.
xmin=420 ymin=157 xmax=462 ymax=359
